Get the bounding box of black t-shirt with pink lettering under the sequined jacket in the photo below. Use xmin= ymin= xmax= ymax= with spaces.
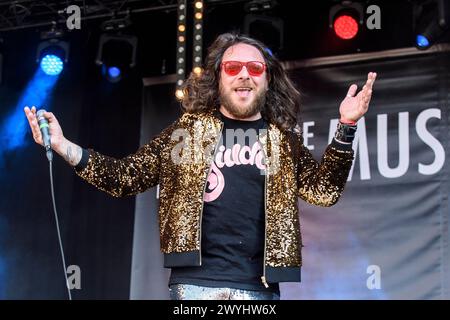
xmin=169 ymin=112 xmax=279 ymax=292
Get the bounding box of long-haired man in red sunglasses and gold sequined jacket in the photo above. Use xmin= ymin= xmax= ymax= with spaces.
xmin=25 ymin=34 xmax=376 ymax=300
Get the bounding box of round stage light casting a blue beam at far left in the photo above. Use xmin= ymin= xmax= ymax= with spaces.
xmin=36 ymin=27 xmax=69 ymax=76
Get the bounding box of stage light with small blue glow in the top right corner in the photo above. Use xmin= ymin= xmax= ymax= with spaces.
xmin=414 ymin=0 xmax=450 ymax=49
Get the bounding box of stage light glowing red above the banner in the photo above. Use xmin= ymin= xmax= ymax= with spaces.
xmin=328 ymin=1 xmax=364 ymax=40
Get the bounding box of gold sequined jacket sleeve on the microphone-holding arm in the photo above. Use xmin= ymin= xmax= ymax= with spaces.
xmin=75 ymin=122 xmax=176 ymax=197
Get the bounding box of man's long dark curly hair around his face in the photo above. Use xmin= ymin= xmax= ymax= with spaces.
xmin=182 ymin=33 xmax=300 ymax=130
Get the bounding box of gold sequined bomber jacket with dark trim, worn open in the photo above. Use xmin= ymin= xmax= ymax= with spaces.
xmin=76 ymin=110 xmax=353 ymax=284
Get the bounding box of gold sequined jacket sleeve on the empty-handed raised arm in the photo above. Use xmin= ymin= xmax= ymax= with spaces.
xmin=297 ymin=134 xmax=354 ymax=207
